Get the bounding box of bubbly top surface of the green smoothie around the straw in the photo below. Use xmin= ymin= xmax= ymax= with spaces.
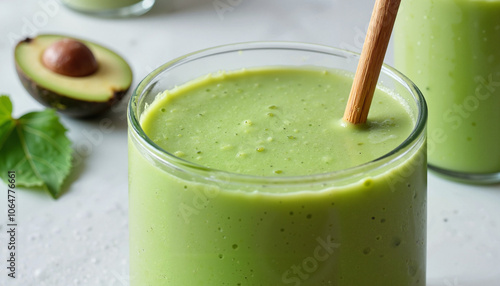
xmin=140 ymin=68 xmax=414 ymax=176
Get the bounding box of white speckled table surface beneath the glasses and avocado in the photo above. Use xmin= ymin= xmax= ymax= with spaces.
xmin=0 ymin=0 xmax=500 ymax=286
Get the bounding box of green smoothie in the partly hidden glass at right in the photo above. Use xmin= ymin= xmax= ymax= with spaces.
xmin=395 ymin=0 xmax=500 ymax=174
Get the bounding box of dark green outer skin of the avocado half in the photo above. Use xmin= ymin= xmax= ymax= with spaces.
xmin=16 ymin=63 xmax=128 ymax=118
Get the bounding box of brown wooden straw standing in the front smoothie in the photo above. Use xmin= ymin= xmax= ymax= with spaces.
xmin=344 ymin=0 xmax=401 ymax=124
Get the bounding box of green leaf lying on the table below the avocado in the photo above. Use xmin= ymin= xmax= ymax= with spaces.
xmin=0 ymin=96 xmax=73 ymax=198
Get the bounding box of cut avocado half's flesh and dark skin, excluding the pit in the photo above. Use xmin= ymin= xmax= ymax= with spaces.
xmin=14 ymin=35 xmax=132 ymax=117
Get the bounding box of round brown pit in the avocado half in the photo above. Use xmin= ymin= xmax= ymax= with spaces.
xmin=42 ymin=38 xmax=99 ymax=77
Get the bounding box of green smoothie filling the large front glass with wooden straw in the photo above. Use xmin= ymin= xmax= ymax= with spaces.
xmin=129 ymin=68 xmax=426 ymax=286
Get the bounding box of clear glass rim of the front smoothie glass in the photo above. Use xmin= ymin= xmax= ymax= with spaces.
xmin=127 ymin=41 xmax=428 ymax=184
